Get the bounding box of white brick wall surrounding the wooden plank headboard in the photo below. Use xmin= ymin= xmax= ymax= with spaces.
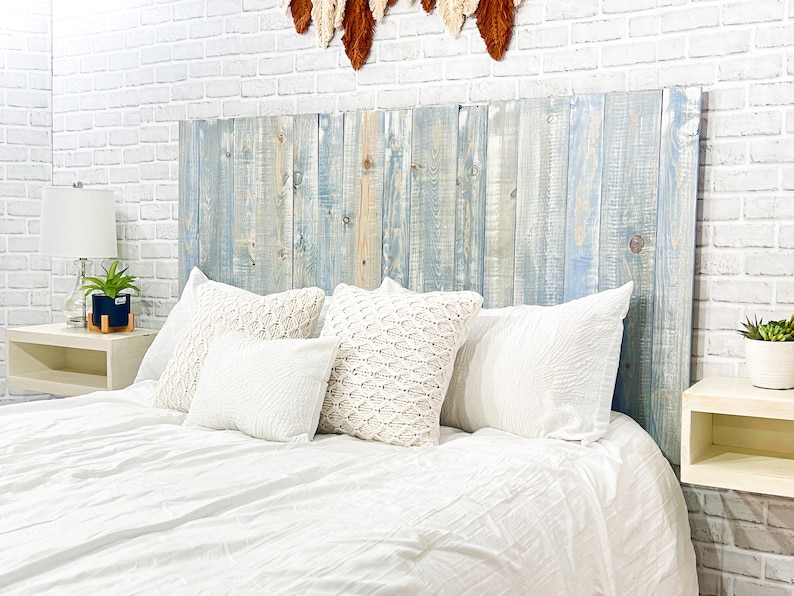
xmin=0 ymin=0 xmax=794 ymax=595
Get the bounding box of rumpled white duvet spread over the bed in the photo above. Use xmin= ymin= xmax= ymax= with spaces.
xmin=0 ymin=382 xmax=697 ymax=595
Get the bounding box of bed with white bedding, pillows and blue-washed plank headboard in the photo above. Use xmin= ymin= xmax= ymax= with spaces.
xmin=0 ymin=90 xmax=700 ymax=594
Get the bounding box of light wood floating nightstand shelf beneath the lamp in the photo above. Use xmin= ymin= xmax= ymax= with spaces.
xmin=6 ymin=323 xmax=157 ymax=395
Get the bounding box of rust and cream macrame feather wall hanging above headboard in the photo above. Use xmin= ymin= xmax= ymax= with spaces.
xmin=279 ymin=0 xmax=521 ymax=70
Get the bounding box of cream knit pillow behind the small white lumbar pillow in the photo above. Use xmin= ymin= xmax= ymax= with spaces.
xmin=154 ymin=284 xmax=325 ymax=412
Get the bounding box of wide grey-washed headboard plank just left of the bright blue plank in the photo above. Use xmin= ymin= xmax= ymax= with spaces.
xmin=513 ymin=97 xmax=571 ymax=306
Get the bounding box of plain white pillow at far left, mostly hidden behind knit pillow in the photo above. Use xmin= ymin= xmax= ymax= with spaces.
xmin=135 ymin=267 xmax=210 ymax=383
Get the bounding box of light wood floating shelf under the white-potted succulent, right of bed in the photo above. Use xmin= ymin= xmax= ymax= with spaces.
xmin=681 ymin=377 xmax=794 ymax=497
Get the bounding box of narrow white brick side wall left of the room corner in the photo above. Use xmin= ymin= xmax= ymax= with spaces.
xmin=0 ymin=0 xmax=52 ymax=403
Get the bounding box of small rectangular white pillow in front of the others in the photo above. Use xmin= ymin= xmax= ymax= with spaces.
xmin=185 ymin=333 xmax=339 ymax=442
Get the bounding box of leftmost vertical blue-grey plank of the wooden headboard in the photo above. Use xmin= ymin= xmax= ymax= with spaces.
xmin=179 ymin=120 xmax=201 ymax=294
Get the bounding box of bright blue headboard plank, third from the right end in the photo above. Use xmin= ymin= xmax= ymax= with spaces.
xmin=563 ymin=95 xmax=604 ymax=301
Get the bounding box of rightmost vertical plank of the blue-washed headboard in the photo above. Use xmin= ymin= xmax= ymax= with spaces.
xmin=646 ymin=87 xmax=701 ymax=463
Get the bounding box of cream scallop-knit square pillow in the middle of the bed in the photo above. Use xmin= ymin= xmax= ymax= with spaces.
xmin=320 ymin=284 xmax=482 ymax=446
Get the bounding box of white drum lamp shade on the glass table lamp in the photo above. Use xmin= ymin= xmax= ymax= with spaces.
xmin=39 ymin=186 xmax=118 ymax=259
